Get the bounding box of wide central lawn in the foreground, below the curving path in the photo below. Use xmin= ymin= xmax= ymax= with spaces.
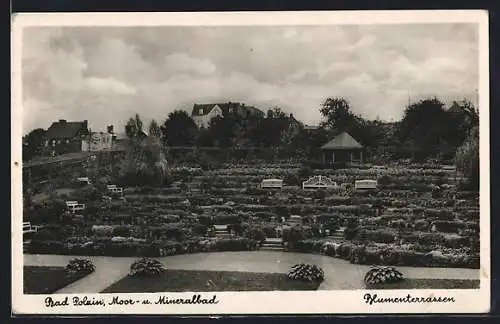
xmin=102 ymin=270 xmax=320 ymax=293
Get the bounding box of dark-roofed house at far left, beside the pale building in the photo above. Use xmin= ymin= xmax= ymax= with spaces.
xmin=45 ymin=119 xmax=90 ymax=154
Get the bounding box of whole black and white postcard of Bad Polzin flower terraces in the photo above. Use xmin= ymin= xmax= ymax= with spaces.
xmin=11 ymin=11 xmax=490 ymax=315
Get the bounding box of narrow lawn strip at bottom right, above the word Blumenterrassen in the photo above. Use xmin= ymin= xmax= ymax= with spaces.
xmin=367 ymin=279 xmax=480 ymax=289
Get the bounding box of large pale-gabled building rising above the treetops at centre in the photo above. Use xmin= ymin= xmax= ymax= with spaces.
xmin=191 ymin=102 xmax=265 ymax=128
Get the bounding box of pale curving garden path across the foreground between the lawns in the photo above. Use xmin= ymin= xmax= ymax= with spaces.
xmin=24 ymin=251 xmax=480 ymax=293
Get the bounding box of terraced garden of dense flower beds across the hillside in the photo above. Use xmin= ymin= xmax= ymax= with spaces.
xmin=25 ymin=163 xmax=479 ymax=269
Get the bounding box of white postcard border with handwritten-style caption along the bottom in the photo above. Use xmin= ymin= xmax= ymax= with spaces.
xmin=11 ymin=10 xmax=491 ymax=315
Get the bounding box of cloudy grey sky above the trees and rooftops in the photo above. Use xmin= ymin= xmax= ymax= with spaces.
xmin=22 ymin=24 xmax=479 ymax=133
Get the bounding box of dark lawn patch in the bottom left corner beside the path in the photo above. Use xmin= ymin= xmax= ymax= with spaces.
xmin=23 ymin=266 xmax=91 ymax=294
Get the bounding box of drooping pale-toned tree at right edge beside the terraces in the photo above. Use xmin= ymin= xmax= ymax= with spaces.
xmin=455 ymin=126 xmax=479 ymax=189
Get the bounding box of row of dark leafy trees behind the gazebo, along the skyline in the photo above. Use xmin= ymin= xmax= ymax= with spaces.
xmin=125 ymin=98 xmax=479 ymax=155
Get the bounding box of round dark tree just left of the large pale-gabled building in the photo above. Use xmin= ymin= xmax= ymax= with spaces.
xmin=161 ymin=110 xmax=198 ymax=146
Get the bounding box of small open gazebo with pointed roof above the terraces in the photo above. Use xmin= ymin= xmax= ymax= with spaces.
xmin=321 ymin=132 xmax=365 ymax=163
